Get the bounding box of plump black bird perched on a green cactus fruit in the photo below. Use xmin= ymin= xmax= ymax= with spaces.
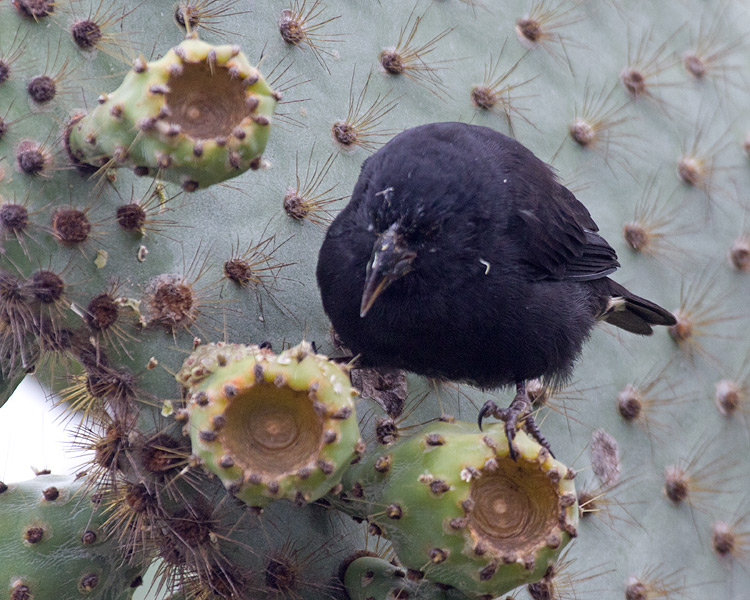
xmin=317 ymin=123 xmax=675 ymax=458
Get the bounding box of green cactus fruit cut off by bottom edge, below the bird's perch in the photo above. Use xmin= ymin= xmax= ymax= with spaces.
xmin=344 ymin=556 xmax=466 ymax=600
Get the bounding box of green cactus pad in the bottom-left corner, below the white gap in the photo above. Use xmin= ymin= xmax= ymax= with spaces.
xmin=0 ymin=475 xmax=145 ymax=600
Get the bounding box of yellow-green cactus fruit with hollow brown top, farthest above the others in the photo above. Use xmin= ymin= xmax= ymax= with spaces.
xmin=67 ymin=38 xmax=278 ymax=191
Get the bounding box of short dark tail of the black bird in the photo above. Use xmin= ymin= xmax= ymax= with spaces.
xmin=597 ymin=278 xmax=677 ymax=335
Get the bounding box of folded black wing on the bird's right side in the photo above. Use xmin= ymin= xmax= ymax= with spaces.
xmin=513 ymin=181 xmax=620 ymax=281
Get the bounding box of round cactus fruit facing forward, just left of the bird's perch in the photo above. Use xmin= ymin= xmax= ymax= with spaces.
xmin=178 ymin=342 xmax=363 ymax=506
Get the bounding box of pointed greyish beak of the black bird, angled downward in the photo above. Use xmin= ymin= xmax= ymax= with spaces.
xmin=359 ymin=224 xmax=417 ymax=317
